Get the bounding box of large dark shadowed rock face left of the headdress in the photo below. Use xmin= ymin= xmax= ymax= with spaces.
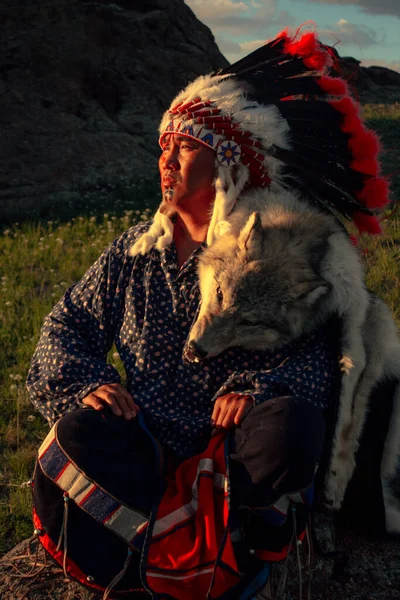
xmin=0 ymin=0 xmax=228 ymax=221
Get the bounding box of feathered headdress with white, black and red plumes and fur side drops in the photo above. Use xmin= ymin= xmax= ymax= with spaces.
xmin=132 ymin=30 xmax=388 ymax=254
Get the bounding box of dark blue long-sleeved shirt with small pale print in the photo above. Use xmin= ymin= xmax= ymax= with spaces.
xmin=27 ymin=223 xmax=338 ymax=457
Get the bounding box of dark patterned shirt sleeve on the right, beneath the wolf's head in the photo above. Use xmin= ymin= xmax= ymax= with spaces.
xmin=214 ymin=330 xmax=339 ymax=408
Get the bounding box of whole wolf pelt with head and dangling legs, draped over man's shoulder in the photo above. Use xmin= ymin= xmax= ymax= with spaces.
xmin=188 ymin=190 xmax=400 ymax=533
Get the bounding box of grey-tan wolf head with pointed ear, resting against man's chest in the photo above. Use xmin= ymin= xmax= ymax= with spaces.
xmin=185 ymin=212 xmax=337 ymax=361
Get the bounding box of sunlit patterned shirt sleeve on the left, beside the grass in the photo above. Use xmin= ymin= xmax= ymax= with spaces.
xmin=27 ymin=225 xmax=144 ymax=425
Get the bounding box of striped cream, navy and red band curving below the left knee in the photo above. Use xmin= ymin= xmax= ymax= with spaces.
xmin=38 ymin=423 xmax=148 ymax=546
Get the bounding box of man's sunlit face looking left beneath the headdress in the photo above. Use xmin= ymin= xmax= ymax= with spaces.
xmin=158 ymin=134 xmax=215 ymax=216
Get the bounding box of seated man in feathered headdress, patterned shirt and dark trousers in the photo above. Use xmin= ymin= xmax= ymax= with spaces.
xmin=28 ymin=27 xmax=394 ymax=600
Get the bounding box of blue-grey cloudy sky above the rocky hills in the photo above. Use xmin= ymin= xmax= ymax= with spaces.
xmin=185 ymin=0 xmax=400 ymax=72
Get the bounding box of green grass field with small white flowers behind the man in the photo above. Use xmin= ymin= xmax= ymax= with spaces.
xmin=0 ymin=105 xmax=400 ymax=556
